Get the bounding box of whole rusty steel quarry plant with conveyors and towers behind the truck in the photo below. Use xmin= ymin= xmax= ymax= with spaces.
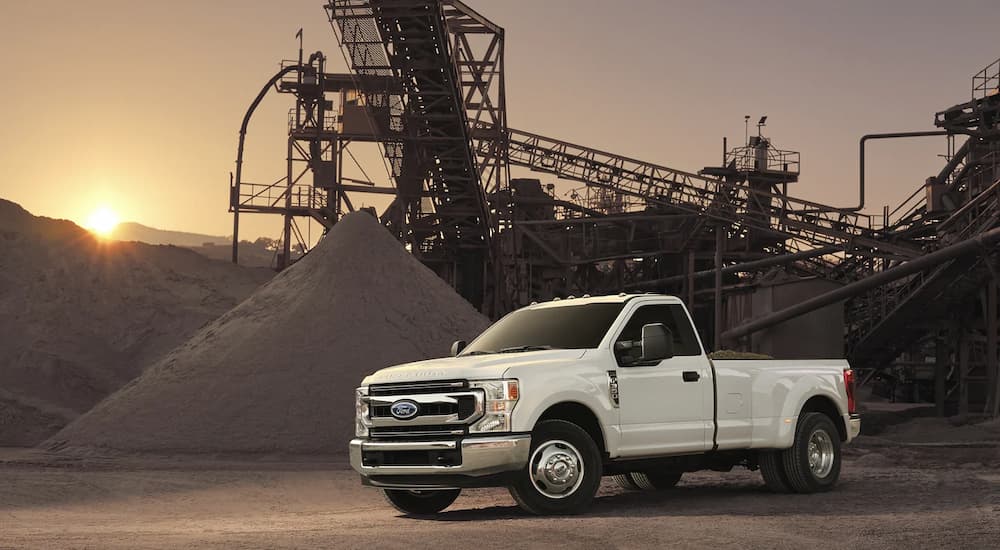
xmin=230 ymin=0 xmax=1000 ymax=415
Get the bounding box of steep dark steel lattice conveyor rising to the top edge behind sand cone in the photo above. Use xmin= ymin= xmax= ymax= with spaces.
xmin=327 ymin=0 xmax=506 ymax=306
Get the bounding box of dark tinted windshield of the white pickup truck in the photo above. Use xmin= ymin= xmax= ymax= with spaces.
xmin=462 ymin=302 xmax=625 ymax=355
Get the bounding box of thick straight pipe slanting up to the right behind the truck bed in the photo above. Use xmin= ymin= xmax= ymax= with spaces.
xmin=722 ymin=228 xmax=1000 ymax=341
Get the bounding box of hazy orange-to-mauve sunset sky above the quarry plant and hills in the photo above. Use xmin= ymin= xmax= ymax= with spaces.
xmin=0 ymin=0 xmax=1000 ymax=244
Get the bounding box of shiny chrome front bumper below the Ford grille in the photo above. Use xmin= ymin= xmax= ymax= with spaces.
xmin=351 ymin=435 xmax=531 ymax=477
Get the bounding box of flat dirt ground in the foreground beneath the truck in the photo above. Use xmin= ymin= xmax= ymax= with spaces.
xmin=0 ymin=448 xmax=1000 ymax=549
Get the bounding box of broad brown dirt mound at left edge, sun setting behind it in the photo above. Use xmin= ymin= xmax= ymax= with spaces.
xmin=0 ymin=200 xmax=272 ymax=445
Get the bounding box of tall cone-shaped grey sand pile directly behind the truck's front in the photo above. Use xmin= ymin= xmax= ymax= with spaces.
xmin=49 ymin=213 xmax=488 ymax=454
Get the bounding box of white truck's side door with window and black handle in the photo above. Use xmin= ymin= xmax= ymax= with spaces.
xmin=614 ymin=304 xmax=714 ymax=457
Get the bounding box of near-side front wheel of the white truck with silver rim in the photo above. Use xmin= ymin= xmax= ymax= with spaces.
xmin=509 ymin=420 xmax=603 ymax=515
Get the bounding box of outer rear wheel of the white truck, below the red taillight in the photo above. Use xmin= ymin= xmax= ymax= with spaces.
xmin=781 ymin=413 xmax=840 ymax=493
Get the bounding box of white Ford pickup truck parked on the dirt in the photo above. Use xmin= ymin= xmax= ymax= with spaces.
xmin=350 ymin=294 xmax=861 ymax=515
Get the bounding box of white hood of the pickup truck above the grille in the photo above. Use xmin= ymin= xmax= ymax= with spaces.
xmin=362 ymin=349 xmax=586 ymax=386
